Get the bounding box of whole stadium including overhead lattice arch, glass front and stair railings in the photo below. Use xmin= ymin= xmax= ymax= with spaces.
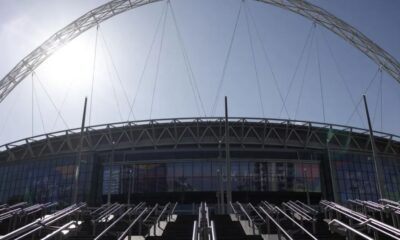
xmin=0 ymin=0 xmax=400 ymax=240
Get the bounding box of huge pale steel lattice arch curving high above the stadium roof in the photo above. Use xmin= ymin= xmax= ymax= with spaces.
xmin=0 ymin=0 xmax=400 ymax=102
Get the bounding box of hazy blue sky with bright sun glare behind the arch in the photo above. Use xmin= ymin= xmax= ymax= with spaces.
xmin=0 ymin=0 xmax=400 ymax=145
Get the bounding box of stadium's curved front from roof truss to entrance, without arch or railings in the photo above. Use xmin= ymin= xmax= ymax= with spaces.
xmin=0 ymin=118 xmax=400 ymax=205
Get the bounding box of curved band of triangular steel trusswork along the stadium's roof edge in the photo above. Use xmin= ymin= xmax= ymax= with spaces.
xmin=0 ymin=118 xmax=400 ymax=161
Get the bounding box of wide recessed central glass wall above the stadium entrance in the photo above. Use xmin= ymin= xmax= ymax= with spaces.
xmin=103 ymin=159 xmax=321 ymax=195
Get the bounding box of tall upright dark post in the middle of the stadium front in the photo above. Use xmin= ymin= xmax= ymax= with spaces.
xmin=225 ymin=96 xmax=232 ymax=213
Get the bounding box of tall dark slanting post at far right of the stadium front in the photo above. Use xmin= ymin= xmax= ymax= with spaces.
xmin=363 ymin=95 xmax=384 ymax=198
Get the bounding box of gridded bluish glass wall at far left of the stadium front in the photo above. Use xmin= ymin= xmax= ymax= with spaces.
xmin=0 ymin=156 xmax=92 ymax=204
